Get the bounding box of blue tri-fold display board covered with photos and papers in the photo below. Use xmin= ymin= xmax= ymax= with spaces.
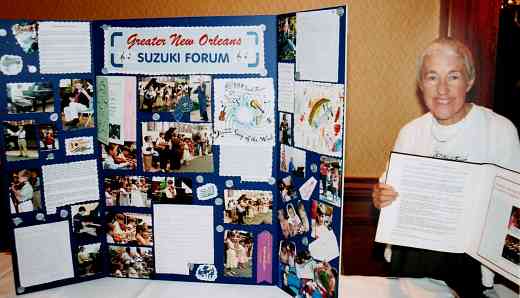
xmin=0 ymin=7 xmax=347 ymax=297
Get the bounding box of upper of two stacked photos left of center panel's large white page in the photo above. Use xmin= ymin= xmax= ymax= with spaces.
xmin=106 ymin=212 xmax=153 ymax=246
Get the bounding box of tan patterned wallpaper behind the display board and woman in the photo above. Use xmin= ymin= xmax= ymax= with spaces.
xmin=0 ymin=0 xmax=440 ymax=177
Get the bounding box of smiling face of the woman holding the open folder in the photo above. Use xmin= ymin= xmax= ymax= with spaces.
xmin=419 ymin=47 xmax=474 ymax=125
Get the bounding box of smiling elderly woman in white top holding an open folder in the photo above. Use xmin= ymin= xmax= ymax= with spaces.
xmin=372 ymin=38 xmax=520 ymax=297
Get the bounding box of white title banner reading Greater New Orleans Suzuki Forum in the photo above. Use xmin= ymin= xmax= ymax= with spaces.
xmin=102 ymin=25 xmax=267 ymax=75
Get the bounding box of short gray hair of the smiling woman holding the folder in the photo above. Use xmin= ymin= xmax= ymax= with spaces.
xmin=417 ymin=37 xmax=476 ymax=82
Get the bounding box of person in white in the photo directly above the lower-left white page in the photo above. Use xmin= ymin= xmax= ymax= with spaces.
xmin=9 ymin=170 xmax=34 ymax=213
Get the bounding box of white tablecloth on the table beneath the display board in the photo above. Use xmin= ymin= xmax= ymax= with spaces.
xmin=0 ymin=253 xmax=518 ymax=298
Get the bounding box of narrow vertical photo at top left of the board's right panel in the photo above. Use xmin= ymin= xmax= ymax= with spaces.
xmin=278 ymin=15 xmax=296 ymax=61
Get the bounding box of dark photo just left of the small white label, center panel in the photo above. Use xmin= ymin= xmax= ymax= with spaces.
xmin=151 ymin=177 xmax=193 ymax=205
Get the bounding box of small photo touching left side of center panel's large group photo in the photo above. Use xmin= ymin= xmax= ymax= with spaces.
xmin=101 ymin=142 xmax=137 ymax=170
